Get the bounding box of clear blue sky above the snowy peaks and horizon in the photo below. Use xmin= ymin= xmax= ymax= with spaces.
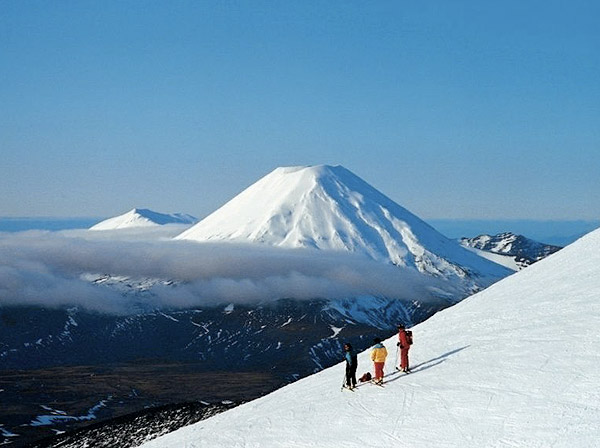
xmin=0 ymin=0 xmax=600 ymax=219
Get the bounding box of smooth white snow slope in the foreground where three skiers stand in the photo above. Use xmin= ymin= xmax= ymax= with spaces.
xmin=144 ymin=230 xmax=600 ymax=448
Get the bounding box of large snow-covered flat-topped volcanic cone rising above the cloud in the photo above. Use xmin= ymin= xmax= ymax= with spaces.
xmin=176 ymin=165 xmax=510 ymax=289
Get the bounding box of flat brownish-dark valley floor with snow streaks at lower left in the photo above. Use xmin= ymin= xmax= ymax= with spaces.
xmin=0 ymin=361 xmax=282 ymax=447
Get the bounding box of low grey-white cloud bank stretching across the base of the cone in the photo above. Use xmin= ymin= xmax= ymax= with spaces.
xmin=0 ymin=232 xmax=448 ymax=314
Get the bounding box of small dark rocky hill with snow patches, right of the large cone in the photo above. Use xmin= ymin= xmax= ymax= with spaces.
xmin=459 ymin=232 xmax=561 ymax=270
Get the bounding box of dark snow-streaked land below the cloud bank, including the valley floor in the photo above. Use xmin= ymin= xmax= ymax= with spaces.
xmin=0 ymin=299 xmax=446 ymax=446
